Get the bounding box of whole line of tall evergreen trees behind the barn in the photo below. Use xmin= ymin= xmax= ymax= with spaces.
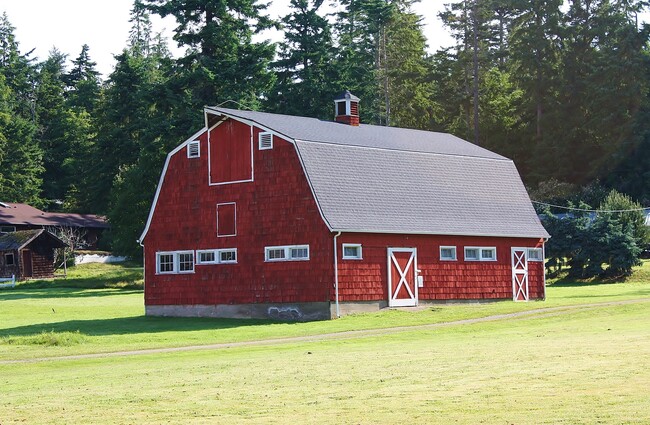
xmin=0 ymin=0 xmax=650 ymax=257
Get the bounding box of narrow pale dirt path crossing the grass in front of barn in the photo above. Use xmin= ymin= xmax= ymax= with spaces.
xmin=0 ymin=298 xmax=650 ymax=365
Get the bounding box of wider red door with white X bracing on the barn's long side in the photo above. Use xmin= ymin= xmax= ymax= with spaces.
xmin=388 ymin=248 xmax=418 ymax=307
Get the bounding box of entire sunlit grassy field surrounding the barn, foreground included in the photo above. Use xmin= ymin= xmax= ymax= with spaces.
xmin=0 ymin=263 xmax=650 ymax=425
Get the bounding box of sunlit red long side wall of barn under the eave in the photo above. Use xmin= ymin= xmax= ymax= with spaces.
xmin=338 ymin=233 xmax=544 ymax=302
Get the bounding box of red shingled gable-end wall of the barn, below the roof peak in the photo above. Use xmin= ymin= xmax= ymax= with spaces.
xmin=144 ymin=117 xmax=334 ymax=310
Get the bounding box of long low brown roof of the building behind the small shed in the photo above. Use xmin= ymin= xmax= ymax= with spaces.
xmin=0 ymin=202 xmax=109 ymax=229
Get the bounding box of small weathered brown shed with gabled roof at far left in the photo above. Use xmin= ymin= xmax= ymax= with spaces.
xmin=0 ymin=229 xmax=66 ymax=280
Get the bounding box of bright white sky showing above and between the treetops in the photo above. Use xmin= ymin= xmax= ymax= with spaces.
xmin=0 ymin=0 xmax=452 ymax=77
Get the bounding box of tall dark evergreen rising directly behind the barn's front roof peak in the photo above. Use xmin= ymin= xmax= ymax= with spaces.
xmin=142 ymin=0 xmax=274 ymax=108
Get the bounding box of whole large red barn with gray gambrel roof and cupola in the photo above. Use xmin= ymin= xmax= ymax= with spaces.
xmin=140 ymin=92 xmax=548 ymax=320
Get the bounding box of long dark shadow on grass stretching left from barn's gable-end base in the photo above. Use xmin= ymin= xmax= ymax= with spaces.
xmin=0 ymin=316 xmax=276 ymax=337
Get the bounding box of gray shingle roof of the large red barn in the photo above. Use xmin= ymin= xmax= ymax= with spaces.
xmin=206 ymin=108 xmax=549 ymax=238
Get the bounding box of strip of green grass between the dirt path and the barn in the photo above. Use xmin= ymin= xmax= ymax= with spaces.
xmin=0 ymin=262 xmax=650 ymax=360
